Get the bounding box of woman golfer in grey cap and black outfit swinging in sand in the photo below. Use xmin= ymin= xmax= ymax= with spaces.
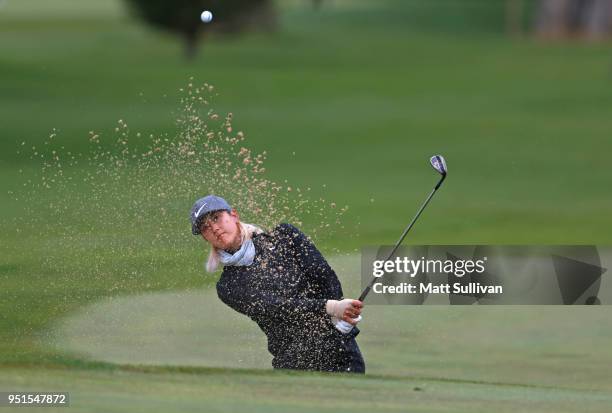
xmin=191 ymin=195 xmax=365 ymax=373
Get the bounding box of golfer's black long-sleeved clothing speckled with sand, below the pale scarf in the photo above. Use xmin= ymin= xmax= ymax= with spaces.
xmin=217 ymin=224 xmax=359 ymax=371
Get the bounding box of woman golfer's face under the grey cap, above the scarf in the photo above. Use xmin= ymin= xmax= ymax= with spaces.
xmin=200 ymin=210 xmax=240 ymax=250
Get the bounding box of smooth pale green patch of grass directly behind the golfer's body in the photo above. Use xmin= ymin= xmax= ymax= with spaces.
xmin=37 ymin=264 xmax=612 ymax=391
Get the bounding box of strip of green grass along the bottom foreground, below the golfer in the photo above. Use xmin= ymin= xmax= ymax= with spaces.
xmin=0 ymin=368 xmax=612 ymax=412
